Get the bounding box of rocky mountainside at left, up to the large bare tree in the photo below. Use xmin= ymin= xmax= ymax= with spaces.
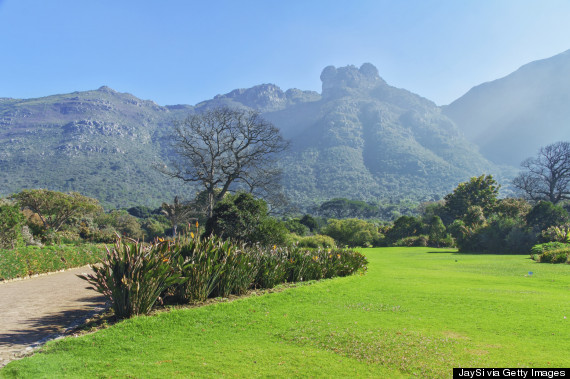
xmin=0 ymin=87 xmax=192 ymax=206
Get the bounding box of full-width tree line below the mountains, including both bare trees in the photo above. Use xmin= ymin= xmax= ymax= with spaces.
xmin=0 ymin=104 xmax=570 ymax=252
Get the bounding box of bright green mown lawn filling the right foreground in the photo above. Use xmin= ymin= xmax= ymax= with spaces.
xmin=0 ymin=248 xmax=570 ymax=378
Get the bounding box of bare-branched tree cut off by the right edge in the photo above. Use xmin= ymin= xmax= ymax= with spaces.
xmin=513 ymin=142 xmax=570 ymax=204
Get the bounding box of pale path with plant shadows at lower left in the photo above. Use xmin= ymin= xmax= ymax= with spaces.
xmin=0 ymin=267 xmax=105 ymax=367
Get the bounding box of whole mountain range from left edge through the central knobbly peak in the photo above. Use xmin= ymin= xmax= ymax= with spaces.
xmin=0 ymin=63 xmax=501 ymax=207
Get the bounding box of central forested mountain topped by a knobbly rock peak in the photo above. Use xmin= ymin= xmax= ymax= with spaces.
xmin=197 ymin=63 xmax=502 ymax=208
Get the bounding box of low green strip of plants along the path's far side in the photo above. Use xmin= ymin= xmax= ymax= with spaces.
xmin=0 ymin=244 xmax=105 ymax=281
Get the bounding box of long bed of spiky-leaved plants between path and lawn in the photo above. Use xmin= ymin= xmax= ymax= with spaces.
xmin=80 ymin=234 xmax=368 ymax=318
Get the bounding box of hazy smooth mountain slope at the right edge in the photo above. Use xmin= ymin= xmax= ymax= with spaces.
xmin=443 ymin=50 xmax=570 ymax=166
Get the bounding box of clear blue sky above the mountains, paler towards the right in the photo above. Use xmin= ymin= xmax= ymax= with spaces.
xmin=0 ymin=0 xmax=570 ymax=105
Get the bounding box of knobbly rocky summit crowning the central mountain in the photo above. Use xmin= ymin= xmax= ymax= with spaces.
xmin=321 ymin=63 xmax=386 ymax=97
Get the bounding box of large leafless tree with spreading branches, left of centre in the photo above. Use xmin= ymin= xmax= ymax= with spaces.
xmin=161 ymin=107 xmax=288 ymax=217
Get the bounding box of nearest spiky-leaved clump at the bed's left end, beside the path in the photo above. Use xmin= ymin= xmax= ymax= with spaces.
xmin=79 ymin=239 xmax=181 ymax=318
